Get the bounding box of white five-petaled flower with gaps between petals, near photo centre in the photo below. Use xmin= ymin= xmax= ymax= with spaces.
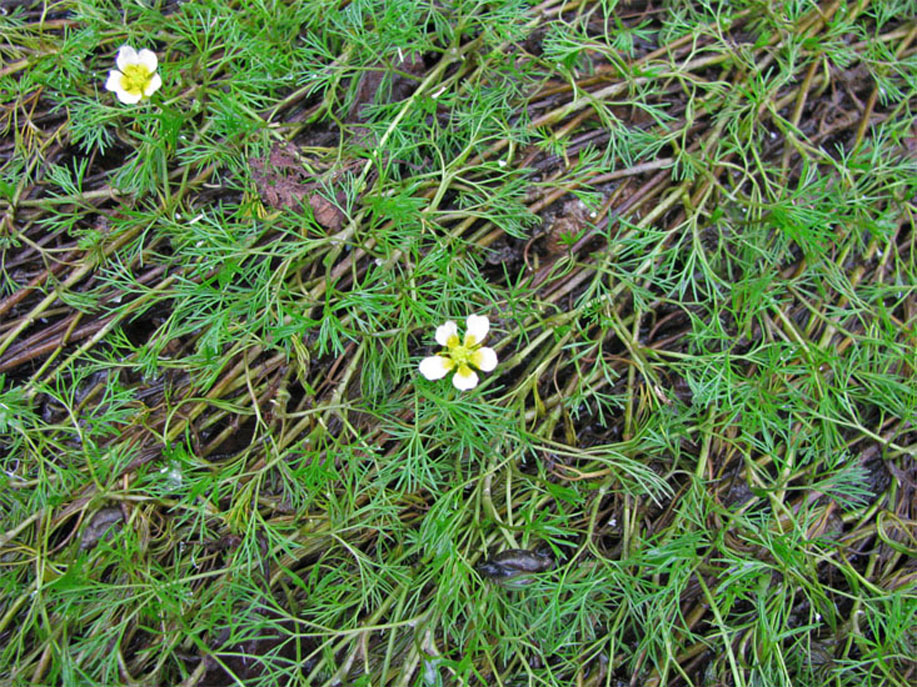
xmin=420 ymin=315 xmax=497 ymax=391
